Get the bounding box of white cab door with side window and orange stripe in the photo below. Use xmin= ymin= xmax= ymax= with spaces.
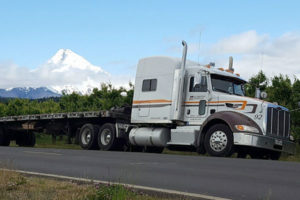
xmin=184 ymin=72 xmax=208 ymax=124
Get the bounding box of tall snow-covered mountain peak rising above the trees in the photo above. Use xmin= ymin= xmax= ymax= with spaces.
xmin=37 ymin=49 xmax=111 ymax=94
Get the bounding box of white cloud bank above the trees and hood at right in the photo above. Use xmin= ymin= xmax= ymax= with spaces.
xmin=204 ymin=31 xmax=300 ymax=79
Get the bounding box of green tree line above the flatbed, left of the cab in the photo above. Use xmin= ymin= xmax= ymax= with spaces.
xmin=0 ymin=83 xmax=133 ymax=117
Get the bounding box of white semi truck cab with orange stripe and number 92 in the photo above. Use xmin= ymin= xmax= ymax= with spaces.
xmin=129 ymin=41 xmax=295 ymax=159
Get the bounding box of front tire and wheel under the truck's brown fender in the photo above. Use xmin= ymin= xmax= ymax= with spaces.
xmin=204 ymin=124 xmax=234 ymax=157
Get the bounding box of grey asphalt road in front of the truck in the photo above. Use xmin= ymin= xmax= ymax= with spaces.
xmin=0 ymin=147 xmax=300 ymax=200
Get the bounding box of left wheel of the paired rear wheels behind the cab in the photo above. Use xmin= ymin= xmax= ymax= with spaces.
xmin=79 ymin=124 xmax=99 ymax=150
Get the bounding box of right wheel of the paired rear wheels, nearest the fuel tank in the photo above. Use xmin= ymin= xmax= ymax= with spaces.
xmin=98 ymin=123 xmax=119 ymax=151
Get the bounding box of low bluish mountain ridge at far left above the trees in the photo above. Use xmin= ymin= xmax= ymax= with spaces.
xmin=0 ymin=87 xmax=61 ymax=99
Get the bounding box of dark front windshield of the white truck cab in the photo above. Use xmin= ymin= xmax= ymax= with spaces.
xmin=211 ymin=74 xmax=245 ymax=96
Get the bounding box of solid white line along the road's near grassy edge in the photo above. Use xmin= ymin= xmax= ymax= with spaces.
xmin=0 ymin=168 xmax=230 ymax=200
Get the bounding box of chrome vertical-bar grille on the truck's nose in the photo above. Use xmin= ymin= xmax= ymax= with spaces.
xmin=267 ymin=107 xmax=290 ymax=138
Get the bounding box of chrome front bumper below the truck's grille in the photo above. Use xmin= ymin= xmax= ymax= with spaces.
xmin=233 ymin=133 xmax=296 ymax=154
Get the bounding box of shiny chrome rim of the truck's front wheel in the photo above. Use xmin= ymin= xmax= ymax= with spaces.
xmin=209 ymin=131 xmax=228 ymax=152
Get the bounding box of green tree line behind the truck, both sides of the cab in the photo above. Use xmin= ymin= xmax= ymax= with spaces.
xmin=0 ymin=71 xmax=300 ymax=140
